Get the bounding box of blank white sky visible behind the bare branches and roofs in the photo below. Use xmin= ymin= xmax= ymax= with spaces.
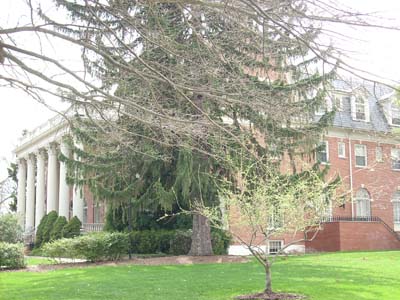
xmin=0 ymin=0 xmax=400 ymax=180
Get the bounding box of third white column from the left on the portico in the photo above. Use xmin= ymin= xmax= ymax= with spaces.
xmin=35 ymin=150 xmax=46 ymax=228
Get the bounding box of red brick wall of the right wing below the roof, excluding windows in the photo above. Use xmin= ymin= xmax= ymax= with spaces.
xmin=231 ymin=128 xmax=400 ymax=252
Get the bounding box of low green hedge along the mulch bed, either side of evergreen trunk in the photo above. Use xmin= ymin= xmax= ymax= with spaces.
xmin=43 ymin=230 xmax=230 ymax=261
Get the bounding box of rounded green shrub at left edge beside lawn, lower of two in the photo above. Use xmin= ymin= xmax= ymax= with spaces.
xmin=0 ymin=242 xmax=25 ymax=269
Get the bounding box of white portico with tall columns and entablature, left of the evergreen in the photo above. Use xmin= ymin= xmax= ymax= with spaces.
xmin=14 ymin=116 xmax=84 ymax=233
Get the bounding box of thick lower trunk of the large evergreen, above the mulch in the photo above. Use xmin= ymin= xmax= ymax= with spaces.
xmin=189 ymin=213 xmax=213 ymax=256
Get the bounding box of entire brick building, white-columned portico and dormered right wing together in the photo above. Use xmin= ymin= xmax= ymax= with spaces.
xmin=15 ymin=81 xmax=400 ymax=254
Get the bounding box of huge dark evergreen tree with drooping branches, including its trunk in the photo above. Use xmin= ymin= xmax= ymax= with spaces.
xmin=51 ymin=0 xmax=334 ymax=254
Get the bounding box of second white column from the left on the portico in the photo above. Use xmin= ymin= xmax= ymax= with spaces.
xmin=25 ymin=154 xmax=35 ymax=231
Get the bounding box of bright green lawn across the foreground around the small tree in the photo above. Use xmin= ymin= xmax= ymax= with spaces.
xmin=0 ymin=251 xmax=400 ymax=300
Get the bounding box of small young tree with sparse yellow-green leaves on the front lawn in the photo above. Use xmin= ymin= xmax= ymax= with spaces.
xmin=196 ymin=158 xmax=342 ymax=299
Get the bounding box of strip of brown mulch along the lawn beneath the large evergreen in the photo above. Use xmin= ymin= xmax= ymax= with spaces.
xmin=20 ymin=255 xmax=249 ymax=272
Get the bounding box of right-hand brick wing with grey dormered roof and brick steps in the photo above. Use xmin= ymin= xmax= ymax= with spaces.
xmin=232 ymin=81 xmax=400 ymax=254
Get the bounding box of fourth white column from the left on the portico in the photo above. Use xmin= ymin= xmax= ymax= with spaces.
xmin=47 ymin=144 xmax=58 ymax=213
